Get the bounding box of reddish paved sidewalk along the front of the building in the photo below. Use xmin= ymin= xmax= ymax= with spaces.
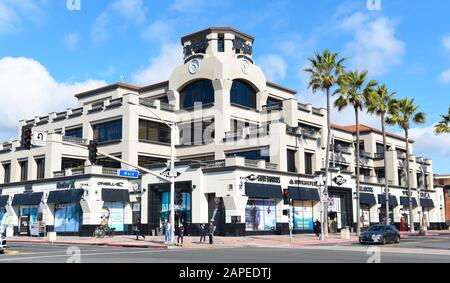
xmin=7 ymin=234 xmax=358 ymax=249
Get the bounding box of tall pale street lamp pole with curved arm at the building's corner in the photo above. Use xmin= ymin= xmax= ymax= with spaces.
xmin=128 ymin=102 xmax=177 ymax=245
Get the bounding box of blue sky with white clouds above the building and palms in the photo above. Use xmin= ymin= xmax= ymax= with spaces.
xmin=0 ymin=0 xmax=450 ymax=173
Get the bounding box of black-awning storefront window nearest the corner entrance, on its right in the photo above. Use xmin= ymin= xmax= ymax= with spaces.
xmin=245 ymin=183 xmax=282 ymax=233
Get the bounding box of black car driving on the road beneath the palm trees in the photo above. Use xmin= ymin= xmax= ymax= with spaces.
xmin=359 ymin=225 xmax=400 ymax=245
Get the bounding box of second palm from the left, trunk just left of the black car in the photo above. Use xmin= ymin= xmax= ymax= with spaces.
xmin=335 ymin=70 xmax=377 ymax=236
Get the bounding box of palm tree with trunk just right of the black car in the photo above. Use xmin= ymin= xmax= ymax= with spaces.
xmin=386 ymin=97 xmax=426 ymax=232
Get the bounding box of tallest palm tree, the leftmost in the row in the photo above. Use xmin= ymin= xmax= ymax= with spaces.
xmin=305 ymin=50 xmax=345 ymax=239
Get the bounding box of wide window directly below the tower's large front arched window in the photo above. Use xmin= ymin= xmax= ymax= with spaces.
xmin=180 ymin=119 xmax=215 ymax=145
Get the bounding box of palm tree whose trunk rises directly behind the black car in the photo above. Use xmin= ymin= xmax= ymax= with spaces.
xmin=365 ymin=85 xmax=396 ymax=225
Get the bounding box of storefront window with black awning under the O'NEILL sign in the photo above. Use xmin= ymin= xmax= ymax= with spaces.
xmin=100 ymin=189 xmax=130 ymax=233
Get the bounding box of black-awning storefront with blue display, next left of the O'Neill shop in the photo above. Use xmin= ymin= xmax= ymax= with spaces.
xmin=47 ymin=189 xmax=84 ymax=233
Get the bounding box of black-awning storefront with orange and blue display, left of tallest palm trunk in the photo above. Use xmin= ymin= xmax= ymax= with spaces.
xmin=288 ymin=187 xmax=320 ymax=232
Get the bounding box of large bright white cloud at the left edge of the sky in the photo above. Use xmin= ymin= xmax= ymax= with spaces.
xmin=0 ymin=57 xmax=106 ymax=133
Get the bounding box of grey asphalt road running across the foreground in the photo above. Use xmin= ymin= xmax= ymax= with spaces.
xmin=0 ymin=237 xmax=450 ymax=263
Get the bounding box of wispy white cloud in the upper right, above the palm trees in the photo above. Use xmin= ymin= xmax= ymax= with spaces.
xmin=340 ymin=13 xmax=406 ymax=75
